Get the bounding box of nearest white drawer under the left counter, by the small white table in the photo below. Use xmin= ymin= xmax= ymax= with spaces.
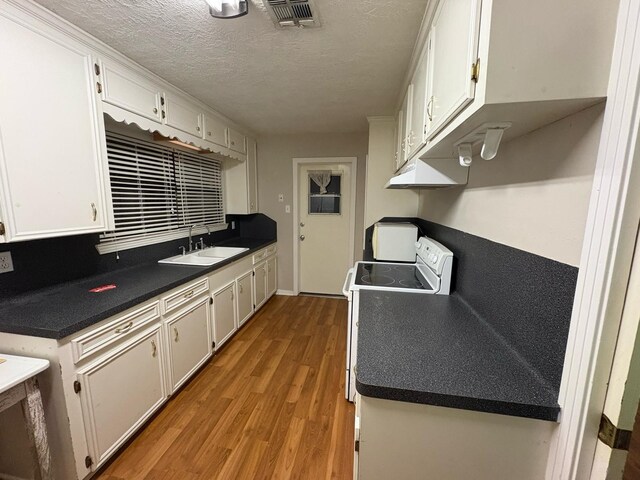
xmin=71 ymin=301 xmax=160 ymax=363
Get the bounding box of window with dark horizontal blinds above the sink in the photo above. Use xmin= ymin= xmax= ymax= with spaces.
xmin=98 ymin=132 xmax=226 ymax=253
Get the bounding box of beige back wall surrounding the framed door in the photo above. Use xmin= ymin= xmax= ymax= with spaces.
xmin=258 ymin=132 xmax=368 ymax=291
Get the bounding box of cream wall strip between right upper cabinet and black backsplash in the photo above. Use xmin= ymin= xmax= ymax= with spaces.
xmin=418 ymin=104 xmax=604 ymax=266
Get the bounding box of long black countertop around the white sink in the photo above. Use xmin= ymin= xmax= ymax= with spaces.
xmin=0 ymin=238 xmax=276 ymax=339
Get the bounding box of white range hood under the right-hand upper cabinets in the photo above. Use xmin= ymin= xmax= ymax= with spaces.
xmin=385 ymin=158 xmax=469 ymax=188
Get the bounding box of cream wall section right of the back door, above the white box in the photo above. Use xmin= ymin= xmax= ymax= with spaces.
xmin=364 ymin=117 xmax=419 ymax=228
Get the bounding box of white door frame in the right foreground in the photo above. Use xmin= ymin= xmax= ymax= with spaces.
xmin=546 ymin=0 xmax=640 ymax=480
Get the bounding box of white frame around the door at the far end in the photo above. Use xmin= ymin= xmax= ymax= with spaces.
xmin=293 ymin=157 xmax=358 ymax=295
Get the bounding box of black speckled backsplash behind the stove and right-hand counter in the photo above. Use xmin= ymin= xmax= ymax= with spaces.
xmin=364 ymin=217 xmax=578 ymax=390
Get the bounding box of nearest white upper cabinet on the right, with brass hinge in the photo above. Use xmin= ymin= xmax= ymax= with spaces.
xmin=401 ymin=0 xmax=616 ymax=160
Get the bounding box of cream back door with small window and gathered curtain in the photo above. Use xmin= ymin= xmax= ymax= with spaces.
xmin=297 ymin=163 xmax=353 ymax=295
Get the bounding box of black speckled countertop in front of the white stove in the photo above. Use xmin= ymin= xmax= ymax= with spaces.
xmin=356 ymin=290 xmax=560 ymax=421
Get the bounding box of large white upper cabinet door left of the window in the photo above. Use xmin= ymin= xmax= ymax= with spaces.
xmin=0 ymin=14 xmax=112 ymax=241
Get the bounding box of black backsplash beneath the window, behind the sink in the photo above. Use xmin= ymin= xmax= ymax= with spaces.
xmin=0 ymin=214 xmax=276 ymax=301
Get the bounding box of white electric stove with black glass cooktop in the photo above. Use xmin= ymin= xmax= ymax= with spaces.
xmin=342 ymin=237 xmax=453 ymax=402
